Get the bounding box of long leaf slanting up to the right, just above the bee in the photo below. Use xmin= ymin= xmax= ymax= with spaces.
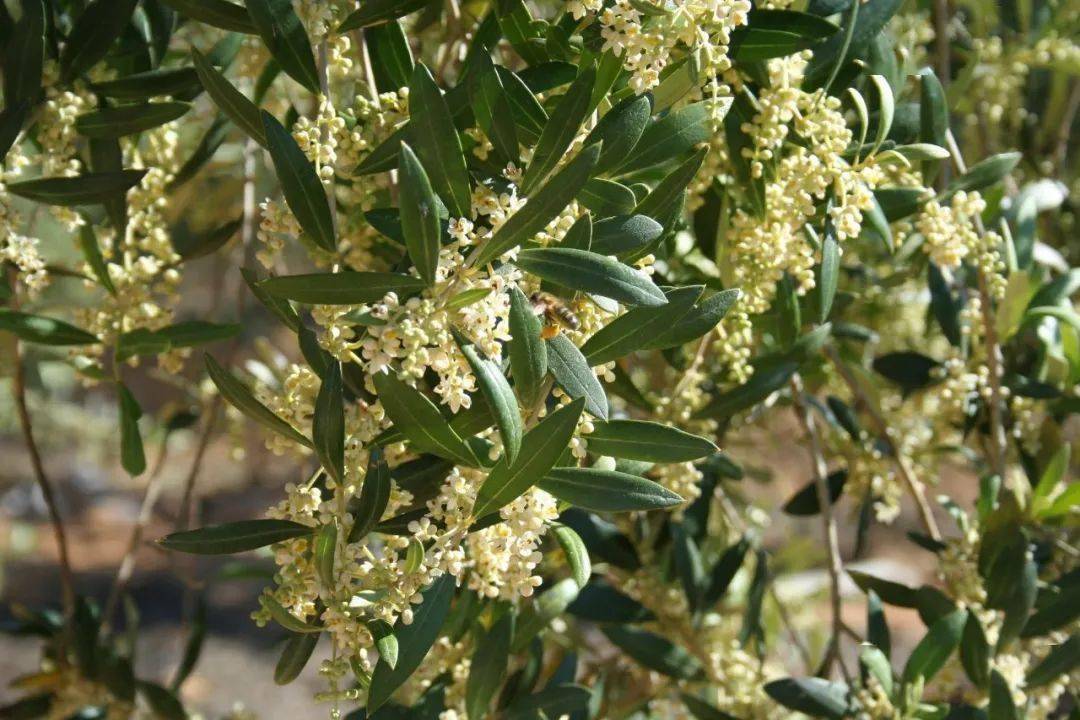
xmin=475 ymin=145 xmax=602 ymax=267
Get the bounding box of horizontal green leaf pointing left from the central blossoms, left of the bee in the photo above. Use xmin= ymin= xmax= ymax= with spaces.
xmin=258 ymin=272 xmax=424 ymax=305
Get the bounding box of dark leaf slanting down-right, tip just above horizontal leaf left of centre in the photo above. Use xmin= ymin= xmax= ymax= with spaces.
xmin=261 ymin=110 xmax=337 ymax=253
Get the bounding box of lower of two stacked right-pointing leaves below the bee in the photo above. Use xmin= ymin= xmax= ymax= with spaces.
xmin=540 ymin=467 xmax=683 ymax=513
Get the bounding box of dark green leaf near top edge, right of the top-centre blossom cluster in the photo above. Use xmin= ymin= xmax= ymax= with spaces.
xmin=730 ymin=9 xmax=840 ymax=63
